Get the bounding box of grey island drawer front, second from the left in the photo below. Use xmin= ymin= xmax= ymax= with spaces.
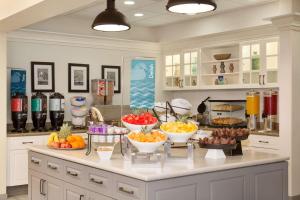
xmin=46 ymin=156 xmax=64 ymax=178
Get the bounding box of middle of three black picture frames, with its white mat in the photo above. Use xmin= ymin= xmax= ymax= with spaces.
xmin=68 ymin=63 xmax=90 ymax=93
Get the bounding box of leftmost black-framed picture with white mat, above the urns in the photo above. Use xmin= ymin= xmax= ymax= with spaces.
xmin=31 ymin=62 xmax=55 ymax=92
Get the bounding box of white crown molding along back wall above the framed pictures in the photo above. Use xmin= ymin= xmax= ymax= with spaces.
xmin=8 ymin=29 xmax=161 ymax=54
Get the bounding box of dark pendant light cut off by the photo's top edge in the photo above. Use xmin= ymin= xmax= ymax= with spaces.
xmin=166 ymin=0 xmax=217 ymax=14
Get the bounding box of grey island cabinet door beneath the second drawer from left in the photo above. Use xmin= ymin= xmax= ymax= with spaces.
xmin=46 ymin=177 xmax=64 ymax=200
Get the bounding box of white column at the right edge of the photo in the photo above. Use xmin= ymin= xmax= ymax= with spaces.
xmin=272 ymin=14 xmax=300 ymax=196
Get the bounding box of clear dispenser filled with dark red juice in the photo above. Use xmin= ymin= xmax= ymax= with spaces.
xmin=262 ymin=90 xmax=278 ymax=131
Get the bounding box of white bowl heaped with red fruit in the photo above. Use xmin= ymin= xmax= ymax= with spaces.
xmin=122 ymin=112 xmax=157 ymax=131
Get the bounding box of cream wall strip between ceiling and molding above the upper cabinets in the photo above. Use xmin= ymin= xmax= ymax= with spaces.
xmin=156 ymin=1 xmax=279 ymax=42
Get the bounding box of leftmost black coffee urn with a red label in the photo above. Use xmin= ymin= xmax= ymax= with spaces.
xmin=11 ymin=93 xmax=28 ymax=132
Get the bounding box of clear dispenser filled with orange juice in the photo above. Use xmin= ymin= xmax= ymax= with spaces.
xmin=246 ymin=91 xmax=260 ymax=130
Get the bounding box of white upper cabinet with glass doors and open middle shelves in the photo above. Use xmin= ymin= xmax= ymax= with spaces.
xmin=164 ymin=38 xmax=279 ymax=90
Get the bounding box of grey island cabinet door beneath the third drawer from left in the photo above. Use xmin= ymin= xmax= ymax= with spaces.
xmin=64 ymin=184 xmax=89 ymax=200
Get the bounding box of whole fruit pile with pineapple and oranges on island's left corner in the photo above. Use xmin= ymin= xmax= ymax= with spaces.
xmin=48 ymin=124 xmax=86 ymax=150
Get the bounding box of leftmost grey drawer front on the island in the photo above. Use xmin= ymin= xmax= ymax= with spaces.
xmin=28 ymin=152 xmax=46 ymax=173
